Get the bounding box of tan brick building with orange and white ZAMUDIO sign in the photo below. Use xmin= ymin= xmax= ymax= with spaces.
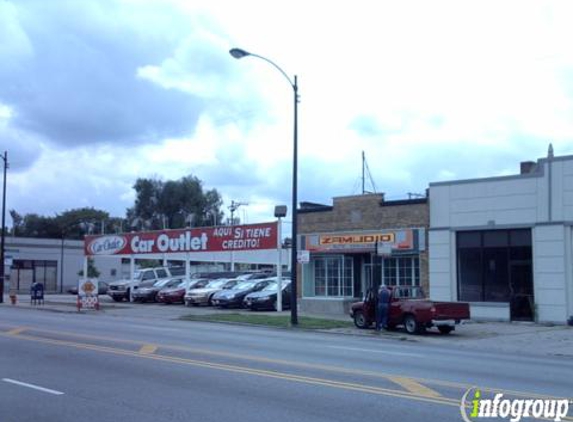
xmin=298 ymin=194 xmax=429 ymax=314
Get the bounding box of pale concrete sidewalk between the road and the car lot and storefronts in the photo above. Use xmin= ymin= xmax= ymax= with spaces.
xmin=0 ymin=294 xmax=573 ymax=358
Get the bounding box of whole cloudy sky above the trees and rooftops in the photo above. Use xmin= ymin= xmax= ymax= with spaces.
xmin=0 ymin=0 xmax=573 ymax=225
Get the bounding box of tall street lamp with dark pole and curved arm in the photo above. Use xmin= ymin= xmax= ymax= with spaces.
xmin=229 ymin=48 xmax=298 ymax=325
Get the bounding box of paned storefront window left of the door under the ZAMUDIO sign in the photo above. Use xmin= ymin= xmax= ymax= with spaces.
xmin=312 ymin=255 xmax=354 ymax=297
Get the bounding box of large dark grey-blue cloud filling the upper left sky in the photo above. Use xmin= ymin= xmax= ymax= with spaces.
xmin=0 ymin=0 xmax=232 ymax=152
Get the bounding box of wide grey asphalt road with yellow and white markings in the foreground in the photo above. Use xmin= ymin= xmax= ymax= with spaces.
xmin=0 ymin=308 xmax=573 ymax=422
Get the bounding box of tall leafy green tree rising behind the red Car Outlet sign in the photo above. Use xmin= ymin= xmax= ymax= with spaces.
xmin=127 ymin=176 xmax=223 ymax=230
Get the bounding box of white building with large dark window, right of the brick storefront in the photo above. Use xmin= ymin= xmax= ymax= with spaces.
xmin=429 ymin=147 xmax=573 ymax=323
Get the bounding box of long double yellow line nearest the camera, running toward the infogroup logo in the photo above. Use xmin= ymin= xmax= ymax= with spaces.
xmin=0 ymin=334 xmax=460 ymax=407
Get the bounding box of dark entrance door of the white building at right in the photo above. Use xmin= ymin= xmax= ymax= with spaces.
xmin=509 ymin=262 xmax=535 ymax=321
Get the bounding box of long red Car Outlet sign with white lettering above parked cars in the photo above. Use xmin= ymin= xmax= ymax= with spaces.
xmin=84 ymin=222 xmax=277 ymax=255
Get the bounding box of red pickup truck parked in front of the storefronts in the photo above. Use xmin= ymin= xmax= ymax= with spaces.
xmin=350 ymin=286 xmax=470 ymax=334
